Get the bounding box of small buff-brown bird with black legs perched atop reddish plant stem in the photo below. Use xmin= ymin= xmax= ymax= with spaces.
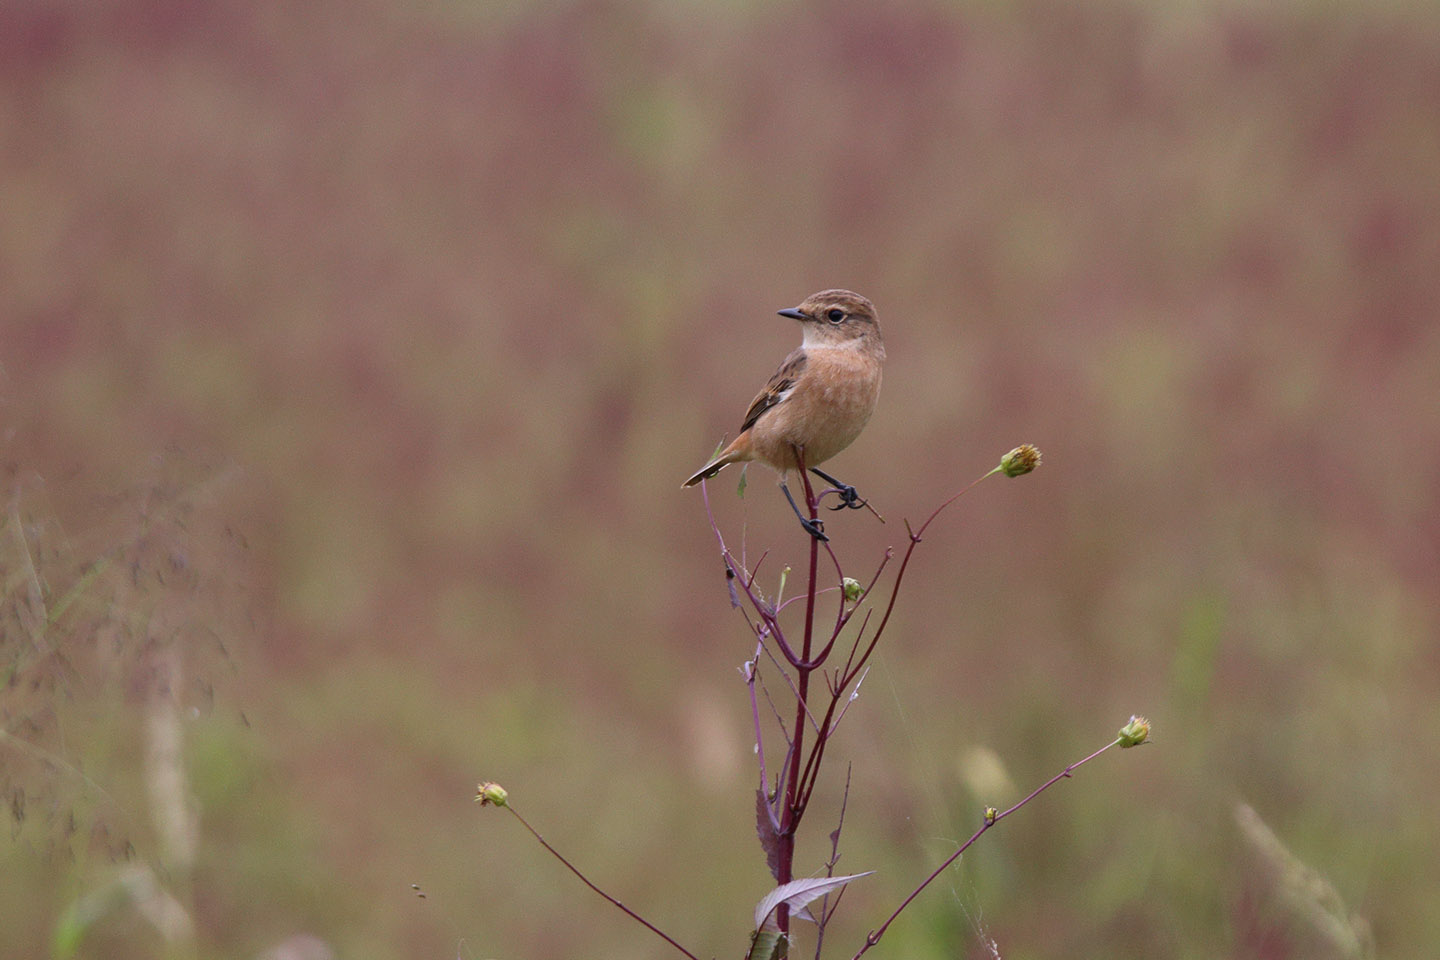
xmin=684 ymin=289 xmax=886 ymax=540
